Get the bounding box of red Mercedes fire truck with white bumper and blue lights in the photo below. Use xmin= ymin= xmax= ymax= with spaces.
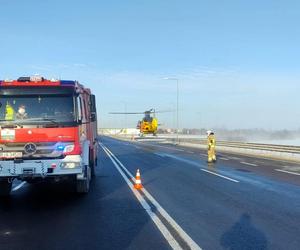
xmin=0 ymin=76 xmax=98 ymax=196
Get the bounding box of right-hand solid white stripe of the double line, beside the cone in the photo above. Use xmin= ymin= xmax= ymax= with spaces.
xmin=100 ymin=145 xmax=201 ymax=250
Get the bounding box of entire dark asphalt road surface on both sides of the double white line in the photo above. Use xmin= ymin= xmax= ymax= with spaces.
xmin=0 ymin=137 xmax=300 ymax=250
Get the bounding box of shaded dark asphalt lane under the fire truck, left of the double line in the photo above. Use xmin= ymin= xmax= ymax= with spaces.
xmin=0 ymin=147 xmax=170 ymax=250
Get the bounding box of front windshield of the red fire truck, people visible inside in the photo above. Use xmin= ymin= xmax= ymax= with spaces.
xmin=0 ymin=95 xmax=76 ymax=126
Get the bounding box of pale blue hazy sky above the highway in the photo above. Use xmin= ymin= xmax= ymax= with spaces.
xmin=0 ymin=0 xmax=300 ymax=129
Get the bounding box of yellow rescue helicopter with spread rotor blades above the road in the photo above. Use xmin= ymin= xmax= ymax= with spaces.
xmin=110 ymin=108 xmax=170 ymax=135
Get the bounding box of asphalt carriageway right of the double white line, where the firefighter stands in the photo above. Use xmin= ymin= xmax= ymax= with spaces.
xmin=101 ymin=137 xmax=300 ymax=249
